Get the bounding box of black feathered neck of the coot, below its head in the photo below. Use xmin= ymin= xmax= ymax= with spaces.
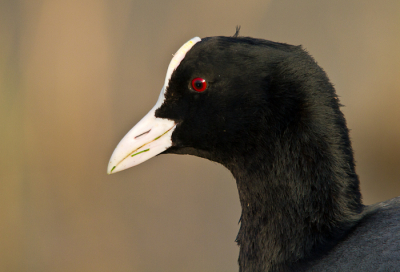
xmin=227 ymin=131 xmax=363 ymax=271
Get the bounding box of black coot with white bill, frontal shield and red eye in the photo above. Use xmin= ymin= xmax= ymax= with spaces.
xmin=108 ymin=32 xmax=400 ymax=272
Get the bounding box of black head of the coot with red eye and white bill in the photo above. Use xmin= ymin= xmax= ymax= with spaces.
xmin=108 ymin=37 xmax=340 ymax=174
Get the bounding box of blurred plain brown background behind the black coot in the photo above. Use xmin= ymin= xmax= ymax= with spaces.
xmin=0 ymin=0 xmax=400 ymax=271
